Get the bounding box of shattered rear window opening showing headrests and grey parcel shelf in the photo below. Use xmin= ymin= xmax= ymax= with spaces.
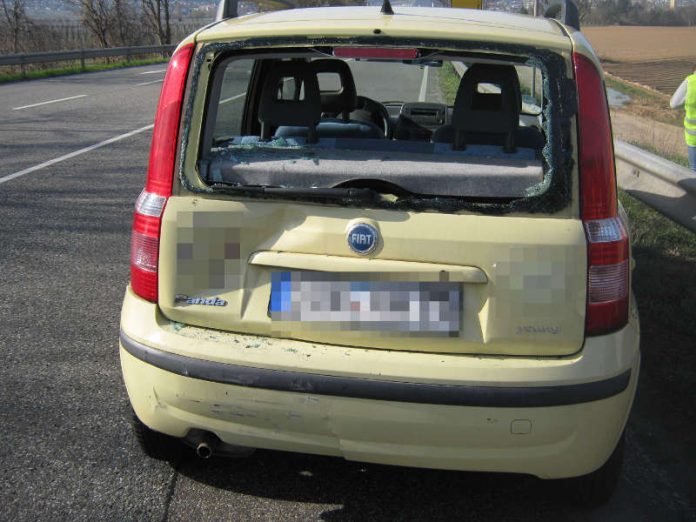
xmin=182 ymin=38 xmax=574 ymax=213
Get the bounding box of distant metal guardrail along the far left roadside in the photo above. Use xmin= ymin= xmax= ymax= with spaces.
xmin=0 ymin=45 xmax=176 ymax=74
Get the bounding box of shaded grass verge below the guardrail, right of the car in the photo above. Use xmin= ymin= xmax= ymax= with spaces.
xmin=619 ymin=189 xmax=696 ymax=408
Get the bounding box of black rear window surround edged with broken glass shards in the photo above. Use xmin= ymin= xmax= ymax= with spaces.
xmin=178 ymin=37 xmax=577 ymax=215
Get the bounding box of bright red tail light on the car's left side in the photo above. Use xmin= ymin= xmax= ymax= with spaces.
xmin=131 ymin=44 xmax=193 ymax=302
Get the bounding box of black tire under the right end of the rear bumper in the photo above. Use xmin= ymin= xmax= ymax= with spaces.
xmin=565 ymin=433 xmax=624 ymax=508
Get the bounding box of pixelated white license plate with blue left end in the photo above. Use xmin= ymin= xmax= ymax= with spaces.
xmin=269 ymin=272 xmax=461 ymax=335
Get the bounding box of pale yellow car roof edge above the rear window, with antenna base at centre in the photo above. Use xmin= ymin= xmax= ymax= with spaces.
xmin=196 ymin=6 xmax=572 ymax=51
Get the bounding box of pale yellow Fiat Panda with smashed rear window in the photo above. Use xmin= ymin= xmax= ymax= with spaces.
xmin=120 ymin=1 xmax=640 ymax=504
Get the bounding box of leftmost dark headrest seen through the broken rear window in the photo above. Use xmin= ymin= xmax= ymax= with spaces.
xmin=259 ymin=60 xmax=321 ymax=143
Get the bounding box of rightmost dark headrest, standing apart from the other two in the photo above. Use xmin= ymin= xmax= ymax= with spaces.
xmin=452 ymin=63 xmax=522 ymax=152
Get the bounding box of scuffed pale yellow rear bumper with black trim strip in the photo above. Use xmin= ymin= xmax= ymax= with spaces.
xmin=121 ymin=291 xmax=640 ymax=478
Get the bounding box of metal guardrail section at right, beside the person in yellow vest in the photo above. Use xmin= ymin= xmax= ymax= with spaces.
xmin=614 ymin=140 xmax=696 ymax=232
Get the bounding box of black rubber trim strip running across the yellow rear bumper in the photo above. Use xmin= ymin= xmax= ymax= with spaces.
xmin=120 ymin=331 xmax=631 ymax=408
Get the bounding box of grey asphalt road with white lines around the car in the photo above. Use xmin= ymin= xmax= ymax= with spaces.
xmin=0 ymin=62 xmax=696 ymax=521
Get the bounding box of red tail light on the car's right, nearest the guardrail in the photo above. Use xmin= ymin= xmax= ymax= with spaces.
xmin=573 ymin=53 xmax=630 ymax=335
